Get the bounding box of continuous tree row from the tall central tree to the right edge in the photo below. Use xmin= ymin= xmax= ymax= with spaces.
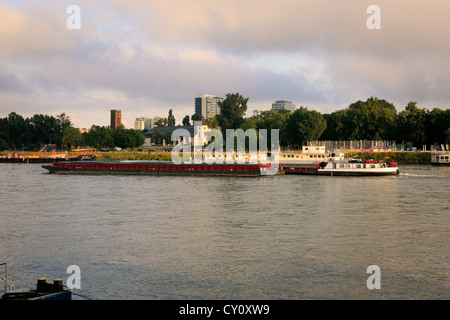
xmin=208 ymin=93 xmax=450 ymax=148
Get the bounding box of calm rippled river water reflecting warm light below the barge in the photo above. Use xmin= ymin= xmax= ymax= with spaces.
xmin=0 ymin=164 xmax=450 ymax=300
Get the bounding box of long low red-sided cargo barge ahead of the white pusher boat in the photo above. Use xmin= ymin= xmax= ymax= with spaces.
xmin=42 ymin=161 xmax=269 ymax=176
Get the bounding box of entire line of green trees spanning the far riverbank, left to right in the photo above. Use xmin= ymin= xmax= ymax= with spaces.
xmin=0 ymin=93 xmax=450 ymax=150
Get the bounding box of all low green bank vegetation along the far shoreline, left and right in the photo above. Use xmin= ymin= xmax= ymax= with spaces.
xmin=0 ymin=151 xmax=431 ymax=165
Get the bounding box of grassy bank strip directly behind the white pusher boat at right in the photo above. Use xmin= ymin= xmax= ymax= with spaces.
xmin=349 ymin=151 xmax=431 ymax=164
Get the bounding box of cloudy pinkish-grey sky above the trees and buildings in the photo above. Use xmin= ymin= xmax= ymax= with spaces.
xmin=0 ymin=0 xmax=450 ymax=127
